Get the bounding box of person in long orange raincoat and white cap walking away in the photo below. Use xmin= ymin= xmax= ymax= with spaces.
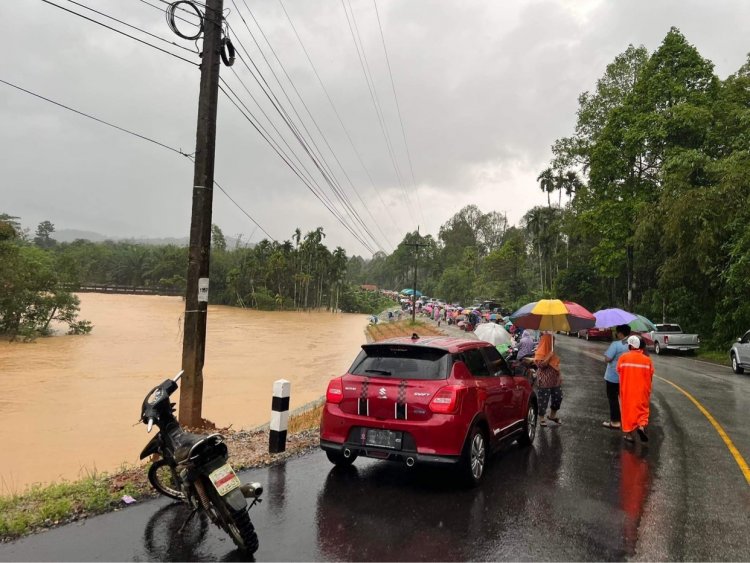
xmin=617 ymin=335 xmax=654 ymax=442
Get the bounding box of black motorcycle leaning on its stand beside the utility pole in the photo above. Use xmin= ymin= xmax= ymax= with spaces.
xmin=141 ymin=371 xmax=263 ymax=555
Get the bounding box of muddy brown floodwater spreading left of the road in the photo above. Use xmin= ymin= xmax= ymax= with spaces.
xmin=0 ymin=293 xmax=367 ymax=494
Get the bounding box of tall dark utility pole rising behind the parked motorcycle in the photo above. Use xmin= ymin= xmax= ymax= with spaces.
xmin=179 ymin=0 xmax=224 ymax=428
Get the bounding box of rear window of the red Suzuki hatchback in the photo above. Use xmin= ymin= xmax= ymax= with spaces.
xmin=349 ymin=344 xmax=451 ymax=379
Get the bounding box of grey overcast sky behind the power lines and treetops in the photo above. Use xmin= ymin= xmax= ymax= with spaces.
xmin=0 ymin=0 xmax=750 ymax=257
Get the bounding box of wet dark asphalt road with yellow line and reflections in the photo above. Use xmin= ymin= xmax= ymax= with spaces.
xmin=0 ymin=337 xmax=750 ymax=561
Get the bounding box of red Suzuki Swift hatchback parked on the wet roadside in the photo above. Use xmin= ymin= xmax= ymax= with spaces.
xmin=320 ymin=335 xmax=537 ymax=484
